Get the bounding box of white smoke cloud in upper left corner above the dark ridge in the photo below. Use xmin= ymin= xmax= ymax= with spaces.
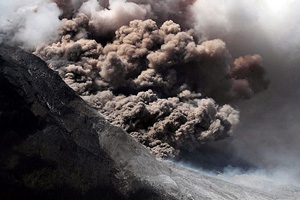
xmin=0 ymin=0 xmax=62 ymax=48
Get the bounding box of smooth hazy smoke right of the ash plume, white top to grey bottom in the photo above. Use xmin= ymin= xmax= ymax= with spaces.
xmin=182 ymin=0 xmax=300 ymax=182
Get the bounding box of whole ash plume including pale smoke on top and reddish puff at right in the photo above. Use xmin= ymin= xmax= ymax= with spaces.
xmin=0 ymin=0 xmax=269 ymax=157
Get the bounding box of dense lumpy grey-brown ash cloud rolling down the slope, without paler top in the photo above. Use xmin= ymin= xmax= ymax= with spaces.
xmin=35 ymin=17 xmax=252 ymax=157
